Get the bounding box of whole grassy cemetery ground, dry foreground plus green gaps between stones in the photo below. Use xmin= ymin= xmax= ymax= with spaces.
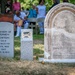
xmin=0 ymin=35 xmax=75 ymax=75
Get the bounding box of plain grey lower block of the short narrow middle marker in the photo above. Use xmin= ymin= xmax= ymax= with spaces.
xmin=21 ymin=41 xmax=33 ymax=60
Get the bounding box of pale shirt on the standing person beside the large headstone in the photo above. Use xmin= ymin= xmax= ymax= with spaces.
xmin=37 ymin=5 xmax=46 ymax=18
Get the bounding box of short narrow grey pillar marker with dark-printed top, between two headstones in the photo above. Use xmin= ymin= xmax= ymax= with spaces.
xmin=21 ymin=29 xmax=33 ymax=60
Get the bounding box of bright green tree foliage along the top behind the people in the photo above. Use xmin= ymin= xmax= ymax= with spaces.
xmin=18 ymin=0 xmax=75 ymax=10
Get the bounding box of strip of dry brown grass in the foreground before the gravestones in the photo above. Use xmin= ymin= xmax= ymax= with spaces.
xmin=0 ymin=60 xmax=75 ymax=75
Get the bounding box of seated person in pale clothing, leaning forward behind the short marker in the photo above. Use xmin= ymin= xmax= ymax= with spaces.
xmin=14 ymin=10 xmax=29 ymax=37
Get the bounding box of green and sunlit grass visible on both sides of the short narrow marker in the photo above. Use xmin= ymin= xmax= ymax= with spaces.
xmin=14 ymin=34 xmax=44 ymax=60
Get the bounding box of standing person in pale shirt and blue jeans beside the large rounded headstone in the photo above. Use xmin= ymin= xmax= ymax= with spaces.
xmin=36 ymin=0 xmax=46 ymax=34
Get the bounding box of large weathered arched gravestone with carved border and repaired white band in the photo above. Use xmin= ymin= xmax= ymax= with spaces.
xmin=44 ymin=3 xmax=75 ymax=62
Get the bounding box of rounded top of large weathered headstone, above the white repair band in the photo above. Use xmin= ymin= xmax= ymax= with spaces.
xmin=44 ymin=3 xmax=75 ymax=33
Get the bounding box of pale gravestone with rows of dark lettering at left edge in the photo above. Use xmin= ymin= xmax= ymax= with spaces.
xmin=0 ymin=22 xmax=14 ymax=58
